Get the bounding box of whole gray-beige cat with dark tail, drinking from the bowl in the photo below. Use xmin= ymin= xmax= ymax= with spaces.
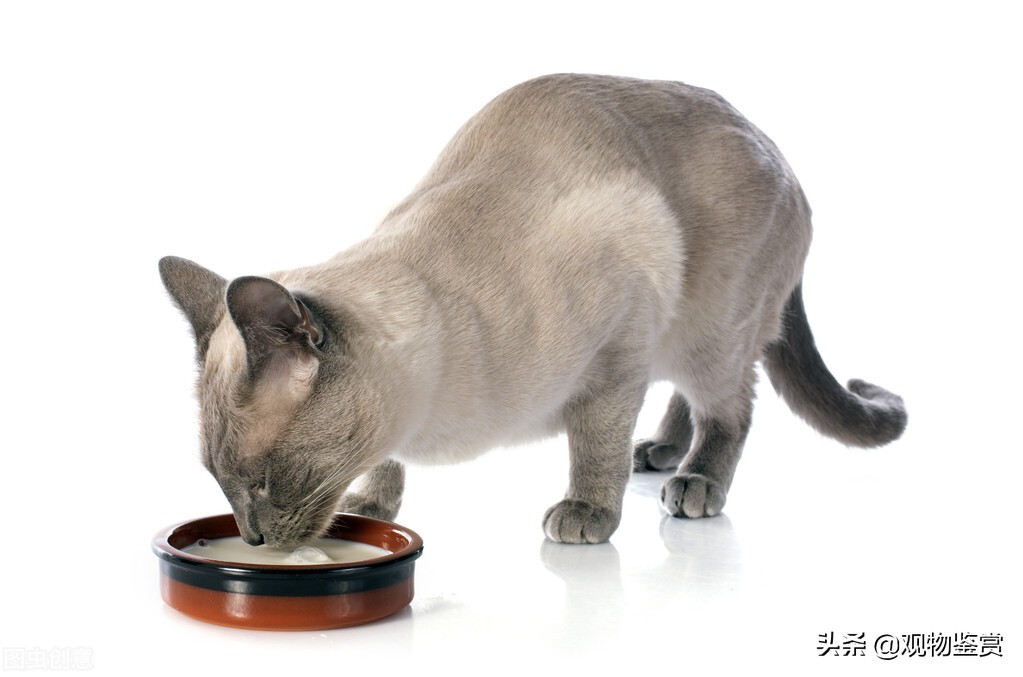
xmin=160 ymin=75 xmax=906 ymax=546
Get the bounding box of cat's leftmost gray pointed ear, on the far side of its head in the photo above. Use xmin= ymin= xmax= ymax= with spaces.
xmin=160 ymin=257 xmax=227 ymax=361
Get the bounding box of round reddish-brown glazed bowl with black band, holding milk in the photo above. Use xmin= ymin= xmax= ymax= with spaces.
xmin=152 ymin=513 xmax=422 ymax=630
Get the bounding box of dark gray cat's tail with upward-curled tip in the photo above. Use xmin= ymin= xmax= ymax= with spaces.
xmin=763 ymin=284 xmax=906 ymax=447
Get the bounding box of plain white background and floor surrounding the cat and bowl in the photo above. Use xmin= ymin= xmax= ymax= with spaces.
xmin=0 ymin=0 xmax=1023 ymax=675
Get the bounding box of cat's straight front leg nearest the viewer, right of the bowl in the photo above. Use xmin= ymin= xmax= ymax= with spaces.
xmin=543 ymin=383 xmax=646 ymax=543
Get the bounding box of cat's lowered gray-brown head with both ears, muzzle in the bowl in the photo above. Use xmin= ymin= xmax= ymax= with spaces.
xmin=160 ymin=257 xmax=377 ymax=546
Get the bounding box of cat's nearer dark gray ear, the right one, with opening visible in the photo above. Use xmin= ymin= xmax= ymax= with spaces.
xmin=226 ymin=277 xmax=323 ymax=371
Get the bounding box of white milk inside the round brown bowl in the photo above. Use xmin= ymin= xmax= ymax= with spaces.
xmin=183 ymin=536 xmax=390 ymax=566
